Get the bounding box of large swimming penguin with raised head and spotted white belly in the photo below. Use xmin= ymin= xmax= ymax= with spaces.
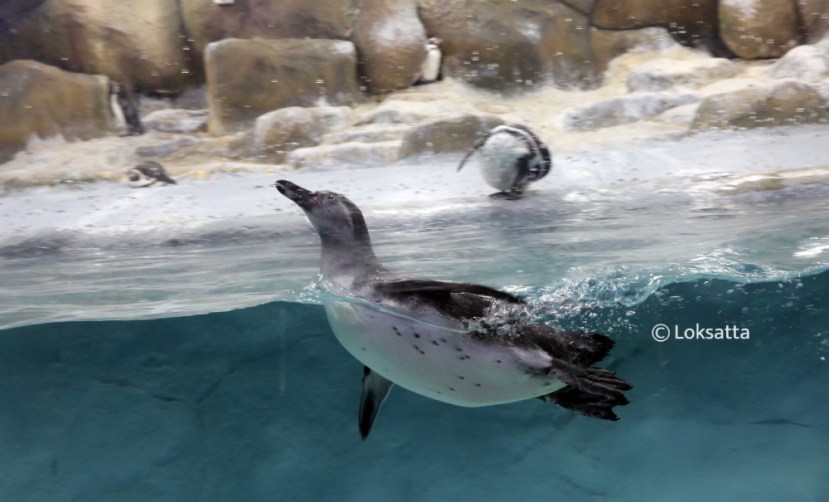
xmin=275 ymin=180 xmax=631 ymax=438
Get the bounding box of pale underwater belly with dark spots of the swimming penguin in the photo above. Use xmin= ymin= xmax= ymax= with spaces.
xmin=325 ymin=302 xmax=564 ymax=407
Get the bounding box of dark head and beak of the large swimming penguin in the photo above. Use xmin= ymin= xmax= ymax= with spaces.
xmin=274 ymin=180 xmax=369 ymax=244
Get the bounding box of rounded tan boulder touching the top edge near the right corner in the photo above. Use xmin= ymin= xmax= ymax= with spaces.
xmin=719 ymin=0 xmax=799 ymax=59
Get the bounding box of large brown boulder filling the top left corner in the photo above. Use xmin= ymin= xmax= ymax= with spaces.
xmin=0 ymin=0 xmax=194 ymax=92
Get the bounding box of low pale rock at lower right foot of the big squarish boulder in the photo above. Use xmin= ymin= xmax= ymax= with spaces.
xmin=253 ymin=106 xmax=354 ymax=163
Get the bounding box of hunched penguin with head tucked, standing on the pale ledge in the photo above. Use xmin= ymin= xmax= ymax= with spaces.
xmin=458 ymin=124 xmax=553 ymax=199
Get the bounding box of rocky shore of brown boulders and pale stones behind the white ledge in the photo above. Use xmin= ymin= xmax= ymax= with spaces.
xmin=0 ymin=0 xmax=829 ymax=189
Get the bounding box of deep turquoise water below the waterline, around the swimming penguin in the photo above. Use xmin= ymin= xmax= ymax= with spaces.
xmin=0 ymin=272 xmax=829 ymax=501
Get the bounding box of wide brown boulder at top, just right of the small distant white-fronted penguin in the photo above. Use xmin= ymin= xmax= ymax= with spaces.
xmin=418 ymin=0 xmax=603 ymax=93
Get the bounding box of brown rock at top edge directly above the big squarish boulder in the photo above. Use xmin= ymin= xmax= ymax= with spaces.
xmin=181 ymin=0 xmax=361 ymax=60
